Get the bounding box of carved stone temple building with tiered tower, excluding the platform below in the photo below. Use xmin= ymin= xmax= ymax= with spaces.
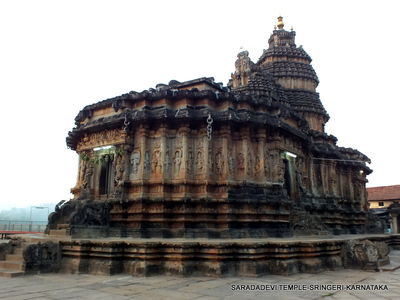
xmin=56 ymin=19 xmax=371 ymax=238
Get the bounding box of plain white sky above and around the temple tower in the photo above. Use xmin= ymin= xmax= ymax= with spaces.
xmin=0 ymin=0 xmax=400 ymax=209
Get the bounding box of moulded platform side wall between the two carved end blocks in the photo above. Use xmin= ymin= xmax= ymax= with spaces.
xmin=61 ymin=239 xmax=342 ymax=276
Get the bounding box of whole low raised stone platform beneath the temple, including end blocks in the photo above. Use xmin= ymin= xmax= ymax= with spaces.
xmin=7 ymin=235 xmax=400 ymax=277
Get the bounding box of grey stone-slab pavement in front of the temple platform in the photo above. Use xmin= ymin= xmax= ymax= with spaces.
xmin=0 ymin=250 xmax=400 ymax=300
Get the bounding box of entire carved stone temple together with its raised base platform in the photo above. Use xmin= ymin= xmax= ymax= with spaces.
xmin=3 ymin=17 xmax=399 ymax=275
